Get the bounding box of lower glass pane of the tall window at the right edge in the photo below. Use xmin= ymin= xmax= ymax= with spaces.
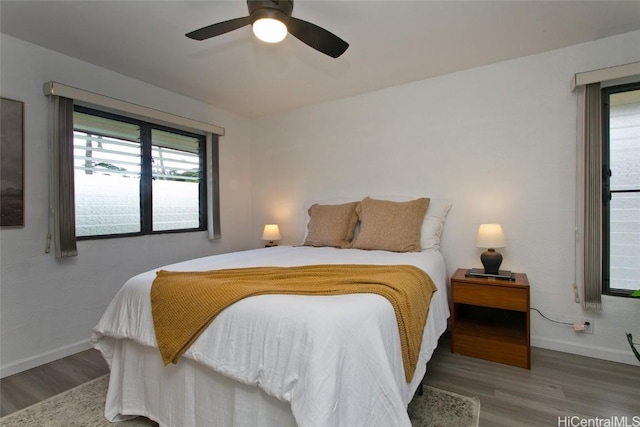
xmin=609 ymin=193 xmax=640 ymax=290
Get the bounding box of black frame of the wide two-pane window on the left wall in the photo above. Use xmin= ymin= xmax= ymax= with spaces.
xmin=73 ymin=104 xmax=208 ymax=240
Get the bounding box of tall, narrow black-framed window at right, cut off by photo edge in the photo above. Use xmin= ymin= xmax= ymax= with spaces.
xmin=602 ymin=83 xmax=640 ymax=296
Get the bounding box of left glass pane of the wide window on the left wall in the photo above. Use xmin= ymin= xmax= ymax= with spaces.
xmin=73 ymin=112 xmax=141 ymax=237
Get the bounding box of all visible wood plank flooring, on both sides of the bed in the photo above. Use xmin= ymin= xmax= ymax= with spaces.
xmin=0 ymin=336 xmax=640 ymax=427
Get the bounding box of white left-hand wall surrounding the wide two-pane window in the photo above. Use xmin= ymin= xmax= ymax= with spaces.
xmin=0 ymin=34 xmax=253 ymax=377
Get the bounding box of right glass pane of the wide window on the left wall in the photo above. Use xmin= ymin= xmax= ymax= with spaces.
xmin=151 ymin=129 xmax=202 ymax=231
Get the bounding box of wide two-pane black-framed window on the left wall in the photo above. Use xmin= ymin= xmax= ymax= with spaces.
xmin=73 ymin=106 xmax=207 ymax=239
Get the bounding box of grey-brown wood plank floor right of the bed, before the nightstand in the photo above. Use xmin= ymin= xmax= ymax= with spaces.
xmin=425 ymin=337 xmax=640 ymax=427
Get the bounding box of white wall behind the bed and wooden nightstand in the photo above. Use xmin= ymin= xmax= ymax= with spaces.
xmin=251 ymin=32 xmax=640 ymax=364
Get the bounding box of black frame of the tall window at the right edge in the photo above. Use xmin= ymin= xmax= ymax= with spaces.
xmin=601 ymin=81 xmax=640 ymax=298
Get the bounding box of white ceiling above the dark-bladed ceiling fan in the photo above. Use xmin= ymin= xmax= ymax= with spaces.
xmin=0 ymin=0 xmax=640 ymax=117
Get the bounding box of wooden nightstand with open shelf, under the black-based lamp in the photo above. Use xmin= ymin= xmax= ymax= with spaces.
xmin=451 ymin=268 xmax=531 ymax=369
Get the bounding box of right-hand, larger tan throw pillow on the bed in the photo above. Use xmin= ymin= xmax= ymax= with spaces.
xmin=350 ymin=197 xmax=429 ymax=252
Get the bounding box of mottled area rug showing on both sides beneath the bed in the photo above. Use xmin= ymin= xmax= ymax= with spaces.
xmin=0 ymin=375 xmax=480 ymax=427
